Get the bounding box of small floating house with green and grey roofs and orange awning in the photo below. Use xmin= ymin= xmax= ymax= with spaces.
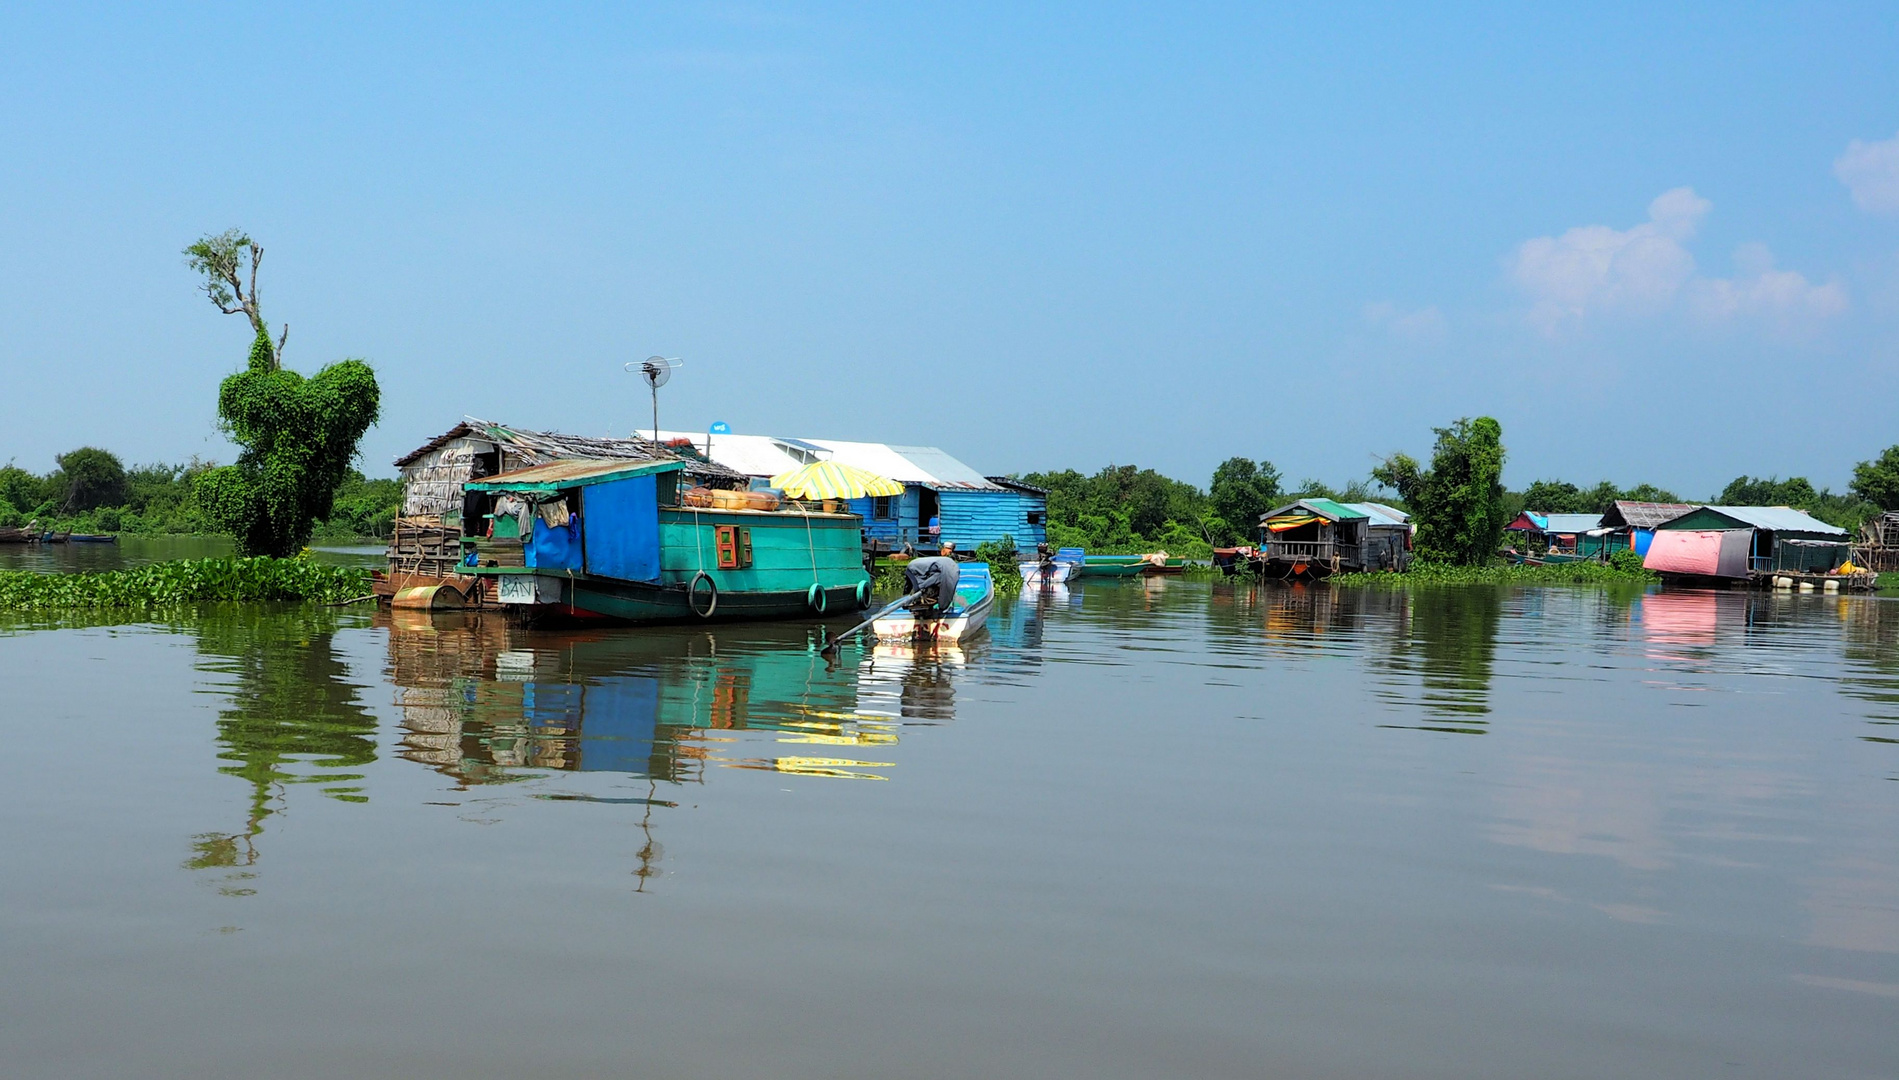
xmin=1255 ymin=499 xmax=1411 ymax=577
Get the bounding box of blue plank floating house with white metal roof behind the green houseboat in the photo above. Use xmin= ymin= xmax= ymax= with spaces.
xmin=661 ymin=431 xmax=1048 ymax=552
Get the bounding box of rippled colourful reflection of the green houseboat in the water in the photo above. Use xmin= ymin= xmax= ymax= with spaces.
xmin=384 ymin=611 xmax=963 ymax=786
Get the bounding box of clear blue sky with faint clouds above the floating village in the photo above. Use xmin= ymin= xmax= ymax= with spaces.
xmin=0 ymin=4 xmax=1899 ymax=497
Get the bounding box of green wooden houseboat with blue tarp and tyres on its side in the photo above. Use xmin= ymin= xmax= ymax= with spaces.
xmin=461 ymin=459 xmax=870 ymax=623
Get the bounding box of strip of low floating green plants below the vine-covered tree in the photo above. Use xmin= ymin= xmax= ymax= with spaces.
xmin=0 ymin=556 xmax=368 ymax=611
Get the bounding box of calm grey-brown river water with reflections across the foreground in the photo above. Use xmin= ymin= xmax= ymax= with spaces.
xmin=0 ymin=581 xmax=1899 ymax=1080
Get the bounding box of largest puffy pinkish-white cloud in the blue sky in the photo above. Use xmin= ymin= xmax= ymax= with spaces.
xmin=1510 ymin=188 xmax=1846 ymax=336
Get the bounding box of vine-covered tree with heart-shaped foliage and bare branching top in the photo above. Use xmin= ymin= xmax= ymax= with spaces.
xmin=184 ymin=230 xmax=382 ymax=556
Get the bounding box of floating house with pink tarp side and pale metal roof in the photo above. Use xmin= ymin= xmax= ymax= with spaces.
xmin=1643 ymin=507 xmax=1850 ymax=581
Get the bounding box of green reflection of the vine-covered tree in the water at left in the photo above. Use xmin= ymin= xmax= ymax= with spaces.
xmin=184 ymin=605 xmax=376 ymax=894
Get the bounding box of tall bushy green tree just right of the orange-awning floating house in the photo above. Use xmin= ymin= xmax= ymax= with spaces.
xmin=1371 ymin=416 xmax=1510 ymax=566
